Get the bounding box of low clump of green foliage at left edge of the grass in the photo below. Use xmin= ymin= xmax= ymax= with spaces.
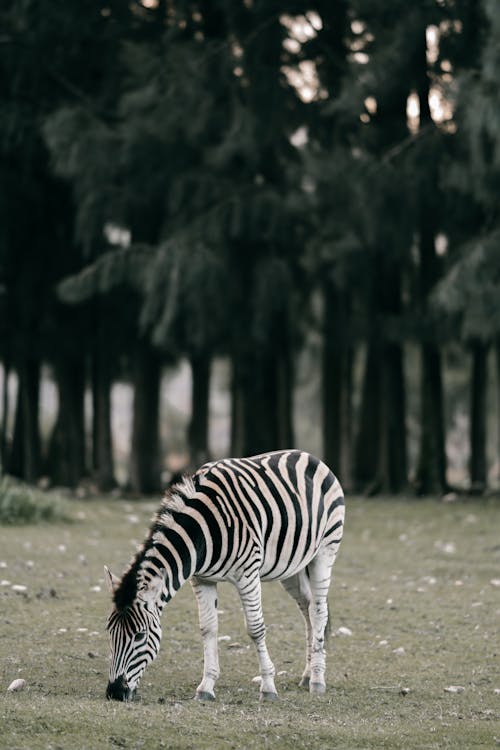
xmin=0 ymin=476 xmax=69 ymax=525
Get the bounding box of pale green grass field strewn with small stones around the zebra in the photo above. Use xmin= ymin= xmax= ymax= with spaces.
xmin=0 ymin=499 xmax=500 ymax=750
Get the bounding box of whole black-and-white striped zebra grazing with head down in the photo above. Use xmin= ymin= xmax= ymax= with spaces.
xmin=105 ymin=450 xmax=344 ymax=700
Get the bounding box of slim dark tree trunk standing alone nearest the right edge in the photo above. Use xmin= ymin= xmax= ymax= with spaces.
xmin=470 ymin=341 xmax=488 ymax=493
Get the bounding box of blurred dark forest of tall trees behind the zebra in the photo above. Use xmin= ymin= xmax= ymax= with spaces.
xmin=0 ymin=0 xmax=500 ymax=494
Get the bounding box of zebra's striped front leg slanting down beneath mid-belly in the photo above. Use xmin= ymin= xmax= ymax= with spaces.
xmin=236 ymin=575 xmax=278 ymax=700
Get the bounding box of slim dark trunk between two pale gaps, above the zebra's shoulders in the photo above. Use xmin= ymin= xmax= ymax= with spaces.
xmin=188 ymin=354 xmax=211 ymax=467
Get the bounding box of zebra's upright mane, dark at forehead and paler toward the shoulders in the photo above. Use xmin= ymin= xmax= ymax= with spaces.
xmin=113 ymin=475 xmax=196 ymax=613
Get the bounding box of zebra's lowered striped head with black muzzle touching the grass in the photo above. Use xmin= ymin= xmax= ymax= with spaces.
xmin=105 ymin=568 xmax=163 ymax=701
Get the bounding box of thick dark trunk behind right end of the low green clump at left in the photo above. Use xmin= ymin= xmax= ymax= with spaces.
xmin=47 ymin=359 xmax=86 ymax=487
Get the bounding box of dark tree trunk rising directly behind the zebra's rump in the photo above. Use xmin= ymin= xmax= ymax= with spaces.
xmin=322 ymin=281 xmax=352 ymax=487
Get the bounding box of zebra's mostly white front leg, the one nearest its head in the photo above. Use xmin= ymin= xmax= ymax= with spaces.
xmin=191 ymin=578 xmax=220 ymax=701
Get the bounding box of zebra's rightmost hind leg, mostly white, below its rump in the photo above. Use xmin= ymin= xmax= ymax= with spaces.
xmin=308 ymin=546 xmax=337 ymax=694
